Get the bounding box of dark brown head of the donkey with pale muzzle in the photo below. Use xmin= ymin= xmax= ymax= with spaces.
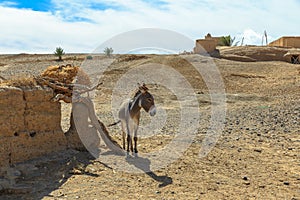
xmin=135 ymin=84 xmax=156 ymax=116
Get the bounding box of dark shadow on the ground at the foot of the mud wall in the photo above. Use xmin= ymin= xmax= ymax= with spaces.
xmin=0 ymin=149 xmax=99 ymax=200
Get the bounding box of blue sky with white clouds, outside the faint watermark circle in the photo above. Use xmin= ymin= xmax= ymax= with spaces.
xmin=0 ymin=0 xmax=300 ymax=53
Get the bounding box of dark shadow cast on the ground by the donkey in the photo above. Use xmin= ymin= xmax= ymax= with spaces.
xmin=126 ymin=157 xmax=173 ymax=188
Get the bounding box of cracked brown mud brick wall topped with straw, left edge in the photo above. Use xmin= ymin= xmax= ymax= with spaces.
xmin=0 ymin=86 xmax=70 ymax=167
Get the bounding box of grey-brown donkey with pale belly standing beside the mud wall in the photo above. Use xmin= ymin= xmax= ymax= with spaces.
xmin=109 ymin=84 xmax=156 ymax=156
